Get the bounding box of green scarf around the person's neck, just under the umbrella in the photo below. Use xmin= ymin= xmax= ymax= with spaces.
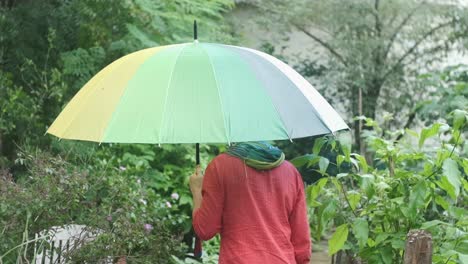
xmin=226 ymin=142 xmax=284 ymax=170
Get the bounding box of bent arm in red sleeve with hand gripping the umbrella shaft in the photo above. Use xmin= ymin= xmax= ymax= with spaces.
xmin=190 ymin=163 xmax=224 ymax=240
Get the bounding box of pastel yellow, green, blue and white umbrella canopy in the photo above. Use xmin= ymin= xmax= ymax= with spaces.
xmin=47 ymin=41 xmax=348 ymax=144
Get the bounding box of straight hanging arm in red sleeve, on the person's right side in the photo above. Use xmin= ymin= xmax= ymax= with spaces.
xmin=289 ymin=171 xmax=312 ymax=264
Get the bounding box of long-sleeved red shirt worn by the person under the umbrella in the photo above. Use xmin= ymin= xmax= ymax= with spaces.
xmin=193 ymin=154 xmax=311 ymax=264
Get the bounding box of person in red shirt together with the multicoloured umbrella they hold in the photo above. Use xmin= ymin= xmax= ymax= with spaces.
xmin=47 ymin=23 xmax=349 ymax=263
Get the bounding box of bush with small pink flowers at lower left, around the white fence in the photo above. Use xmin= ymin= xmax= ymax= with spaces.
xmin=0 ymin=148 xmax=186 ymax=263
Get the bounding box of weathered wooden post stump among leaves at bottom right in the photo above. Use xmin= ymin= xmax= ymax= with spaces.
xmin=403 ymin=230 xmax=432 ymax=264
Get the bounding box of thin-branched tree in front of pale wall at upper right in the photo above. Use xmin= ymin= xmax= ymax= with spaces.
xmin=257 ymin=0 xmax=468 ymax=152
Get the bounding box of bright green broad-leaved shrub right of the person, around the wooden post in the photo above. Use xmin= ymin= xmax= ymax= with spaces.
xmin=303 ymin=110 xmax=468 ymax=264
